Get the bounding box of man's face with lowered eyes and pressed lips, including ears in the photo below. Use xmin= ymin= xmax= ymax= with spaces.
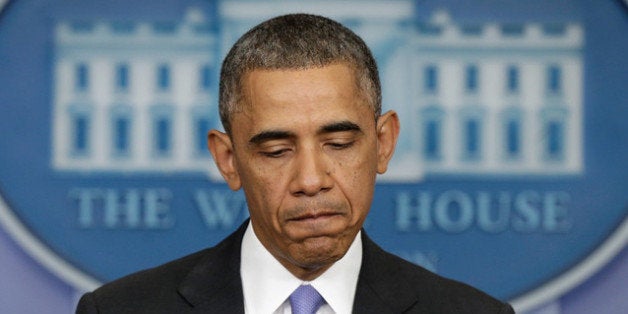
xmin=210 ymin=64 xmax=398 ymax=279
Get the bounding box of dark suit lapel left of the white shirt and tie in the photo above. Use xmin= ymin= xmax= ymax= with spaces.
xmin=178 ymin=220 xmax=248 ymax=313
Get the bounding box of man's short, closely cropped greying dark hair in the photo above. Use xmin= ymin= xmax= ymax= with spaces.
xmin=219 ymin=14 xmax=382 ymax=134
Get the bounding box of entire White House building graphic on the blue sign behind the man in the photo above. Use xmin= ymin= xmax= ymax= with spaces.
xmin=52 ymin=1 xmax=584 ymax=181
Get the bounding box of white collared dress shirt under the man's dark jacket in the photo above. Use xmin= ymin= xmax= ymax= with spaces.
xmin=240 ymin=222 xmax=362 ymax=314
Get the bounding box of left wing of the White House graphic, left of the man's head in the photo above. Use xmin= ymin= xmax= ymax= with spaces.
xmin=53 ymin=10 xmax=218 ymax=172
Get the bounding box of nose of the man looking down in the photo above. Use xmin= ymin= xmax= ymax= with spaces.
xmin=291 ymin=147 xmax=333 ymax=196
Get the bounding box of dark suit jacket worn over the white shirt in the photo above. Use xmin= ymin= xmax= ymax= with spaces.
xmin=76 ymin=223 xmax=513 ymax=314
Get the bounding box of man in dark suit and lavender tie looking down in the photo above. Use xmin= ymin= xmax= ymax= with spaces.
xmin=77 ymin=14 xmax=512 ymax=313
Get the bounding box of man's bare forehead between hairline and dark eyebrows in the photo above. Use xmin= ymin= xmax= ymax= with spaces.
xmin=231 ymin=64 xmax=375 ymax=141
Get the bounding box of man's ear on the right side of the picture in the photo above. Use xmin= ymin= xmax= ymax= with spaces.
xmin=377 ymin=110 xmax=399 ymax=174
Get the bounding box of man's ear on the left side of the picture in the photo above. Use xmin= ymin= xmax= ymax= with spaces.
xmin=207 ymin=130 xmax=242 ymax=191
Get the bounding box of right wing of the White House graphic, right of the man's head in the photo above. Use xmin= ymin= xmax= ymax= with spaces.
xmin=384 ymin=11 xmax=583 ymax=178
